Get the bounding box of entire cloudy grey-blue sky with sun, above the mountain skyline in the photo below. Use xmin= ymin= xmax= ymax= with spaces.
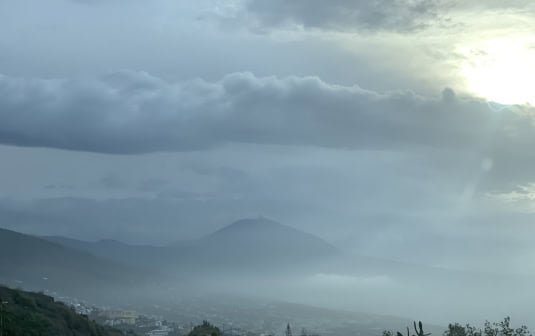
xmin=0 ymin=0 xmax=535 ymax=273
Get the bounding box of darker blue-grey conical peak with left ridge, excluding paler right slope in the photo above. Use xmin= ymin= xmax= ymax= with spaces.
xmin=43 ymin=218 xmax=339 ymax=272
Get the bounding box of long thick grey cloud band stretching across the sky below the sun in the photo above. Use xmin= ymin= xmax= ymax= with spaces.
xmin=0 ymin=71 xmax=535 ymax=155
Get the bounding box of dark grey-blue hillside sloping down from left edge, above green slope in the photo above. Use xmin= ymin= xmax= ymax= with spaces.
xmin=0 ymin=229 xmax=144 ymax=296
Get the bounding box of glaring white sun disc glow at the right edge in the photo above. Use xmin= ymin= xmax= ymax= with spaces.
xmin=461 ymin=38 xmax=535 ymax=105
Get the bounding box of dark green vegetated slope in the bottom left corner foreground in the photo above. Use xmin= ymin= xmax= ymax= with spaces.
xmin=0 ymin=286 xmax=123 ymax=336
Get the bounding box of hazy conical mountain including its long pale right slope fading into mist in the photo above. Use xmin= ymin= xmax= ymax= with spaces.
xmin=35 ymin=218 xmax=469 ymax=281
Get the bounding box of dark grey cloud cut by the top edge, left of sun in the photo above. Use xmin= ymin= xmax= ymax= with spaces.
xmin=245 ymin=0 xmax=443 ymax=31
